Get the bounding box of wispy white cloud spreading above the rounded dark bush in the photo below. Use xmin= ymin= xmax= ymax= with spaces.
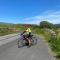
xmin=23 ymin=10 xmax=60 ymax=24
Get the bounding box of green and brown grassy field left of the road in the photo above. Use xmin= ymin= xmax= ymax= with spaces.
xmin=0 ymin=24 xmax=24 ymax=36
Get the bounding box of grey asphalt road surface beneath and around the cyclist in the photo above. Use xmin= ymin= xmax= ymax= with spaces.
xmin=0 ymin=36 xmax=55 ymax=60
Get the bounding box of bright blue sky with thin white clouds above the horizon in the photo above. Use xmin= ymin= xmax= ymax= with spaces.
xmin=0 ymin=0 xmax=60 ymax=24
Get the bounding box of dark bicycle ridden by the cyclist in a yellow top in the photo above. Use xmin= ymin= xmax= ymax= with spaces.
xmin=17 ymin=35 xmax=37 ymax=48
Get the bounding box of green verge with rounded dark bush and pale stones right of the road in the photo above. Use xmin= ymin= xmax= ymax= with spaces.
xmin=35 ymin=21 xmax=60 ymax=59
